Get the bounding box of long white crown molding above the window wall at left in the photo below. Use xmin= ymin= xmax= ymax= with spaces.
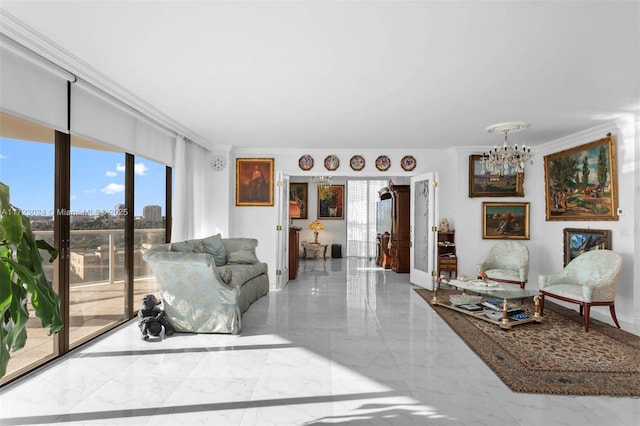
xmin=0 ymin=8 xmax=215 ymax=150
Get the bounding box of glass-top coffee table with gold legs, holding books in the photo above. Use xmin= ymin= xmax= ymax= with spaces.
xmin=431 ymin=280 xmax=542 ymax=330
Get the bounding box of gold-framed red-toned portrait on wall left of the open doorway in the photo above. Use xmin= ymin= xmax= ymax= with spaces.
xmin=236 ymin=158 xmax=273 ymax=206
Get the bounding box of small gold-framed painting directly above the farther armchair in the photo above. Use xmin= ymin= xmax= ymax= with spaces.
xmin=482 ymin=202 xmax=529 ymax=240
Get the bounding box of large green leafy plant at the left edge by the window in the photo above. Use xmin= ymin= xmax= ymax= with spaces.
xmin=0 ymin=182 xmax=64 ymax=377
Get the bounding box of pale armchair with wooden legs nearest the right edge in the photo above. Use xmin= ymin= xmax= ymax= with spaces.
xmin=538 ymin=250 xmax=622 ymax=331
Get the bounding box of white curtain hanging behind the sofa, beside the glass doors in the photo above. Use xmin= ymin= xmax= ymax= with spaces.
xmin=171 ymin=136 xmax=211 ymax=241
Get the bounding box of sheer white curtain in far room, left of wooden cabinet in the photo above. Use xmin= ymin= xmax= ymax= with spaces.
xmin=347 ymin=180 xmax=387 ymax=258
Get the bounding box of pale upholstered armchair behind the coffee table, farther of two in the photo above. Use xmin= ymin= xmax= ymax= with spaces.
xmin=478 ymin=241 xmax=529 ymax=288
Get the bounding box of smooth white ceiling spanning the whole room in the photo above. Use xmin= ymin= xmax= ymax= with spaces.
xmin=0 ymin=0 xmax=640 ymax=149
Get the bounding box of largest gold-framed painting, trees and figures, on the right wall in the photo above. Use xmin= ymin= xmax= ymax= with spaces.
xmin=544 ymin=133 xmax=618 ymax=220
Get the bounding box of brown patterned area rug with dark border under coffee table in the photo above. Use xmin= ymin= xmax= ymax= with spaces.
xmin=415 ymin=289 xmax=640 ymax=397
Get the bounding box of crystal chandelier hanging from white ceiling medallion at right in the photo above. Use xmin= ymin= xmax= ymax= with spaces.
xmin=480 ymin=121 xmax=533 ymax=176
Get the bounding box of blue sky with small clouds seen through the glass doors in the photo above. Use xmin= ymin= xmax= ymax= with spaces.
xmin=0 ymin=138 xmax=166 ymax=216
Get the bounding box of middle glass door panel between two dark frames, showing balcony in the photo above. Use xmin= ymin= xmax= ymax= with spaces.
xmin=68 ymin=137 xmax=129 ymax=348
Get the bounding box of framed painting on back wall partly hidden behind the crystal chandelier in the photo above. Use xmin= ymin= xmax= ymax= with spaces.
xmin=469 ymin=155 xmax=524 ymax=198
